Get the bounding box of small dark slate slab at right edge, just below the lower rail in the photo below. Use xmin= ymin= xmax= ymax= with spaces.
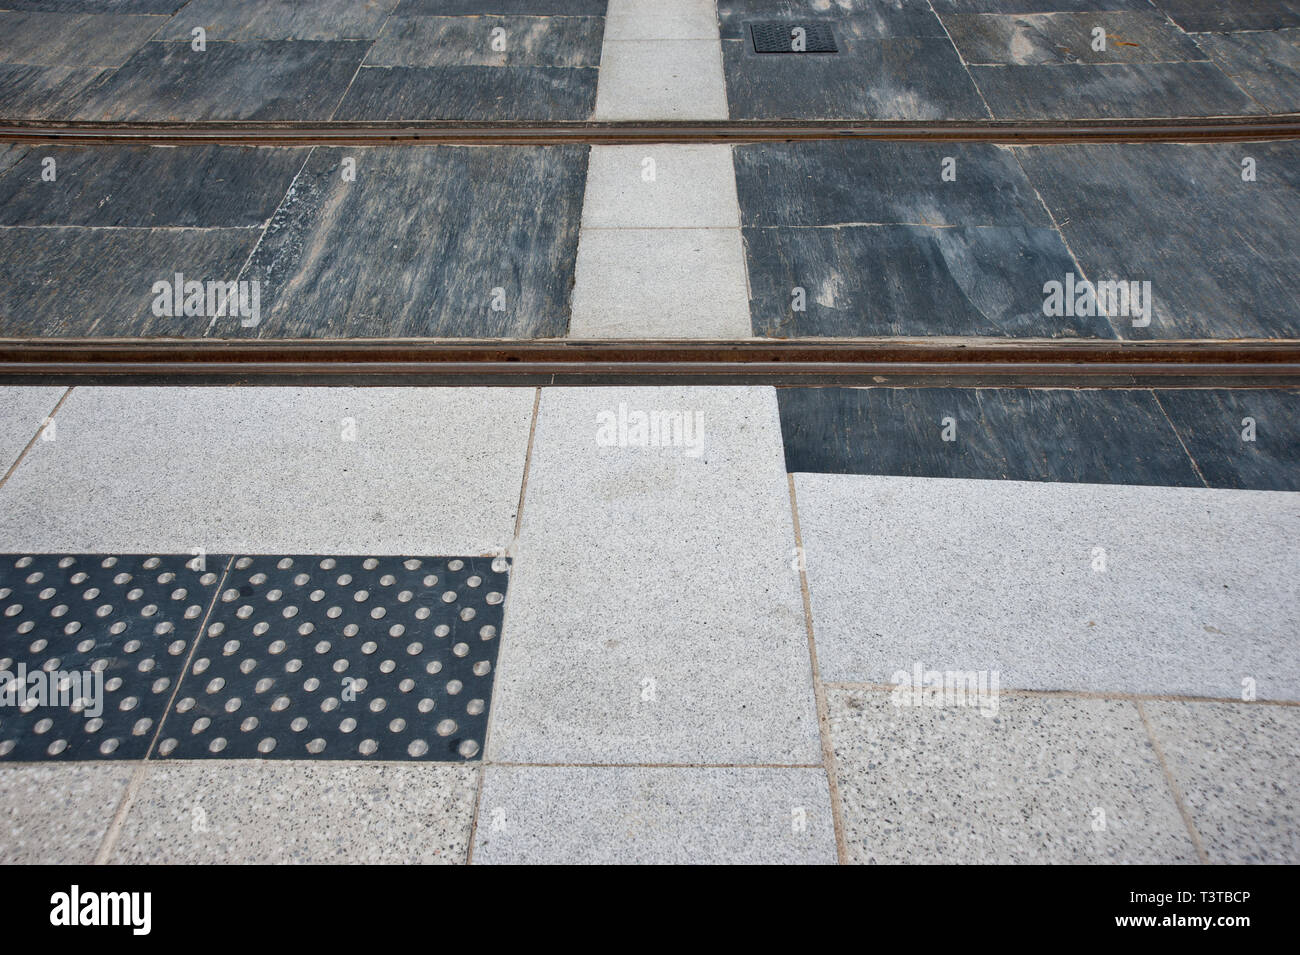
xmin=1157 ymin=390 xmax=1300 ymax=491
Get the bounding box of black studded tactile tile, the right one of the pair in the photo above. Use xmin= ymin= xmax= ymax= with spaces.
xmin=157 ymin=556 xmax=510 ymax=761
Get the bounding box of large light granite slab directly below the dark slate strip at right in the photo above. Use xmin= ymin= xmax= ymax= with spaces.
xmin=794 ymin=474 xmax=1300 ymax=700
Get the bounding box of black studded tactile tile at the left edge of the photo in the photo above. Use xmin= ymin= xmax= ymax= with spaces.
xmin=0 ymin=554 xmax=228 ymax=761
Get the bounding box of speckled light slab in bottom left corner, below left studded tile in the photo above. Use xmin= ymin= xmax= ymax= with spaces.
xmin=0 ymin=763 xmax=135 ymax=865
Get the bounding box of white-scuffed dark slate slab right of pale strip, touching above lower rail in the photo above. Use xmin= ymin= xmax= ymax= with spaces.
xmin=744 ymin=226 xmax=1115 ymax=338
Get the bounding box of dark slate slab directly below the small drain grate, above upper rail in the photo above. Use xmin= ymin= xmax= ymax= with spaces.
xmin=723 ymin=35 xmax=988 ymax=120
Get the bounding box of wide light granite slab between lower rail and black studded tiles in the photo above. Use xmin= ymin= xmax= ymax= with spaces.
xmin=0 ymin=387 xmax=534 ymax=555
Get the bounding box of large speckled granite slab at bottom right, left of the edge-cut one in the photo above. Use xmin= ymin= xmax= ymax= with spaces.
xmin=827 ymin=689 xmax=1197 ymax=864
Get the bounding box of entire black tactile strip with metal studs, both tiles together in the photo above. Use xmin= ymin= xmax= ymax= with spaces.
xmin=0 ymin=555 xmax=510 ymax=761
